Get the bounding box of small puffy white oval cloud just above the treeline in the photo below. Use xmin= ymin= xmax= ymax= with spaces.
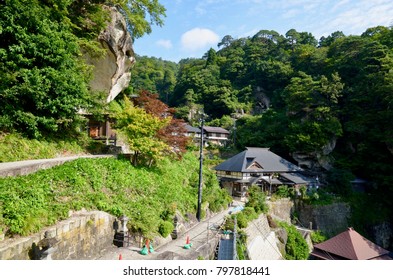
xmin=181 ymin=28 xmax=220 ymax=51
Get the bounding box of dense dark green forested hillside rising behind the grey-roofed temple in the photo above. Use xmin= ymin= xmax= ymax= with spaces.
xmin=131 ymin=26 xmax=393 ymax=238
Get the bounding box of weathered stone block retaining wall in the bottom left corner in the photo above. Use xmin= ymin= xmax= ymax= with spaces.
xmin=0 ymin=211 xmax=115 ymax=260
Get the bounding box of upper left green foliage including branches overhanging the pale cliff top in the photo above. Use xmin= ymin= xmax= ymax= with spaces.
xmin=0 ymin=0 xmax=165 ymax=138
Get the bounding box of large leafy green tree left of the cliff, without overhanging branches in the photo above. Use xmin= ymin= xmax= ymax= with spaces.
xmin=0 ymin=0 xmax=91 ymax=137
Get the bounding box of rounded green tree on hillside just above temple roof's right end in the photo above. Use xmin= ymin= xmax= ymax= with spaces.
xmin=283 ymin=73 xmax=343 ymax=152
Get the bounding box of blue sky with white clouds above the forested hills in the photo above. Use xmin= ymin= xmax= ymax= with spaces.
xmin=134 ymin=0 xmax=393 ymax=62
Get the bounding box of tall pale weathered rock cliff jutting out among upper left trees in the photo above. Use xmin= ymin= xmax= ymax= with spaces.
xmin=85 ymin=7 xmax=135 ymax=103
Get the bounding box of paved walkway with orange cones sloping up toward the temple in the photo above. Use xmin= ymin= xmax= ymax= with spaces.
xmin=99 ymin=201 xmax=245 ymax=260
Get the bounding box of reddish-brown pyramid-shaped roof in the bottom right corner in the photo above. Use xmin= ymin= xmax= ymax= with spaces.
xmin=311 ymin=228 xmax=393 ymax=260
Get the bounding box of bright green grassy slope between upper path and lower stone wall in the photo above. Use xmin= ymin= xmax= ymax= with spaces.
xmin=0 ymin=153 xmax=230 ymax=237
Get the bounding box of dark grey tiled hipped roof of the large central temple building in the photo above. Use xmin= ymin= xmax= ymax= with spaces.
xmin=215 ymin=148 xmax=302 ymax=172
